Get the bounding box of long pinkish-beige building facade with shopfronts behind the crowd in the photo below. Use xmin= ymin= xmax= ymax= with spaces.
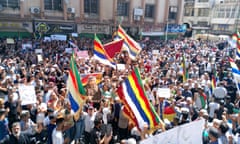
xmin=0 ymin=0 xmax=183 ymax=37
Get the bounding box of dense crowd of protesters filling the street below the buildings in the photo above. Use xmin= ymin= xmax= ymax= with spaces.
xmin=0 ymin=34 xmax=240 ymax=144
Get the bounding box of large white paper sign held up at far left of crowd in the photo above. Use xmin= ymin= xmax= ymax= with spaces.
xmin=18 ymin=84 xmax=37 ymax=105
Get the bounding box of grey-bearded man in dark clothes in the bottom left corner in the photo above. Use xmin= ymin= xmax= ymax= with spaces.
xmin=0 ymin=122 xmax=31 ymax=144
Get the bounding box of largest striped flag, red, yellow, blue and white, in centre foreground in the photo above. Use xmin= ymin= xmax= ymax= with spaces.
xmin=117 ymin=68 xmax=163 ymax=130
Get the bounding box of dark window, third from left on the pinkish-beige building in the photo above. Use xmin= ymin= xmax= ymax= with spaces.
xmin=84 ymin=0 xmax=99 ymax=14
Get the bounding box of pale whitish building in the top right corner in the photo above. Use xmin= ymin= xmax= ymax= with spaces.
xmin=182 ymin=0 xmax=240 ymax=35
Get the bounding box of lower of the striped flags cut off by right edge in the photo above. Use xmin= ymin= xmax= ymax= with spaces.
xmin=229 ymin=58 xmax=240 ymax=91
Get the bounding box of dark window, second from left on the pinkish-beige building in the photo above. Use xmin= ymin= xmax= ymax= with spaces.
xmin=44 ymin=0 xmax=62 ymax=10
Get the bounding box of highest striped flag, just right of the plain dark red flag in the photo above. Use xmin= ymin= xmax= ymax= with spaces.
xmin=114 ymin=25 xmax=142 ymax=59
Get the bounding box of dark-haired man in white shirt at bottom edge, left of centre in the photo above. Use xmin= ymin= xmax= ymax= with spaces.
xmin=52 ymin=117 xmax=64 ymax=144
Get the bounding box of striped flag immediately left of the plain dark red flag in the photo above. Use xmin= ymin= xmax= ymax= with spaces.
xmin=93 ymin=35 xmax=116 ymax=68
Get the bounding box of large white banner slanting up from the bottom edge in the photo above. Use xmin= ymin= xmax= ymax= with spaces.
xmin=140 ymin=120 xmax=204 ymax=144
